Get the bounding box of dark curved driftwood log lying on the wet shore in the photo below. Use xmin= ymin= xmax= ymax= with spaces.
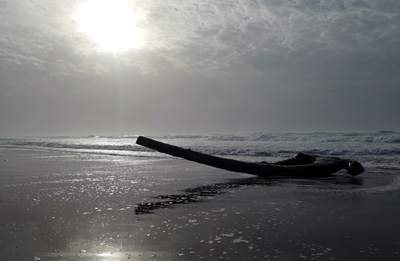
xmin=136 ymin=136 xmax=364 ymax=177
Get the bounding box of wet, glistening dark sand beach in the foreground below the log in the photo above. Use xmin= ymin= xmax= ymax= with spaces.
xmin=0 ymin=149 xmax=400 ymax=260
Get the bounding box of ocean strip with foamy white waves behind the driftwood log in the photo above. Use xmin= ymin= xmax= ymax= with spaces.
xmin=0 ymin=131 xmax=400 ymax=170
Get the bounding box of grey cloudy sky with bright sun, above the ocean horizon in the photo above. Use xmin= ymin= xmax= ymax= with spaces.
xmin=0 ymin=0 xmax=400 ymax=136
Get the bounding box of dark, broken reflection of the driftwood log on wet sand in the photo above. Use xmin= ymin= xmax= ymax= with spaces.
xmin=135 ymin=175 xmax=363 ymax=215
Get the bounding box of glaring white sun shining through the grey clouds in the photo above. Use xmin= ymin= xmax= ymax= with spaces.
xmin=76 ymin=0 xmax=143 ymax=53
